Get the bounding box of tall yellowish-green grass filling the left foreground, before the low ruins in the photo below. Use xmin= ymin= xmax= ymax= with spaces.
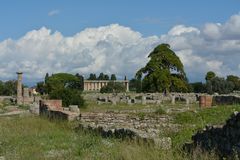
xmin=0 ymin=117 xmax=188 ymax=160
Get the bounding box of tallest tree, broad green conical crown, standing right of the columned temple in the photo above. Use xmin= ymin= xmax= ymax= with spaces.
xmin=135 ymin=44 xmax=188 ymax=92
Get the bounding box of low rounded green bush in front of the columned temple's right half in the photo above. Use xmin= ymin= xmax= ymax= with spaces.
xmin=100 ymin=82 xmax=126 ymax=93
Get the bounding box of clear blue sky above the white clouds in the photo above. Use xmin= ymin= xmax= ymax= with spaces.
xmin=0 ymin=0 xmax=240 ymax=40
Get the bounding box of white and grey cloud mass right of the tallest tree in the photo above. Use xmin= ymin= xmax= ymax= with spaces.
xmin=160 ymin=14 xmax=240 ymax=80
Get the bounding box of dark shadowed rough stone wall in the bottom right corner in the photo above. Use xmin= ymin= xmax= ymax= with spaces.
xmin=184 ymin=112 xmax=240 ymax=157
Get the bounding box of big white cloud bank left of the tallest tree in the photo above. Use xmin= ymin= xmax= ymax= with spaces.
xmin=0 ymin=24 xmax=159 ymax=80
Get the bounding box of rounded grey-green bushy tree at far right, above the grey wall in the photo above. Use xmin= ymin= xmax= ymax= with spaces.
xmin=206 ymin=77 xmax=234 ymax=94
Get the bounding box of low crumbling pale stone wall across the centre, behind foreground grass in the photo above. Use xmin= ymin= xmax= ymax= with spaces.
xmin=80 ymin=112 xmax=176 ymax=149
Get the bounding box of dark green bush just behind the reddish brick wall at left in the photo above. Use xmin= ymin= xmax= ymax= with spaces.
xmin=49 ymin=88 xmax=84 ymax=107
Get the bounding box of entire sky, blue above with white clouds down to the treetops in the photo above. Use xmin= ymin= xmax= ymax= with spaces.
xmin=0 ymin=0 xmax=240 ymax=83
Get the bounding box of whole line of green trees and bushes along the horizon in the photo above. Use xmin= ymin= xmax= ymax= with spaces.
xmin=0 ymin=44 xmax=240 ymax=105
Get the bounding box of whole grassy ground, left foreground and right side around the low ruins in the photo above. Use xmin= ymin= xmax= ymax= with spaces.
xmin=0 ymin=103 xmax=240 ymax=160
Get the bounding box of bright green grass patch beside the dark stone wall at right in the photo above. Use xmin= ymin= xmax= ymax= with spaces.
xmin=168 ymin=105 xmax=240 ymax=148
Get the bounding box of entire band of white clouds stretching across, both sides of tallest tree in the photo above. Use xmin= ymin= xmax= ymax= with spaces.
xmin=0 ymin=14 xmax=240 ymax=81
